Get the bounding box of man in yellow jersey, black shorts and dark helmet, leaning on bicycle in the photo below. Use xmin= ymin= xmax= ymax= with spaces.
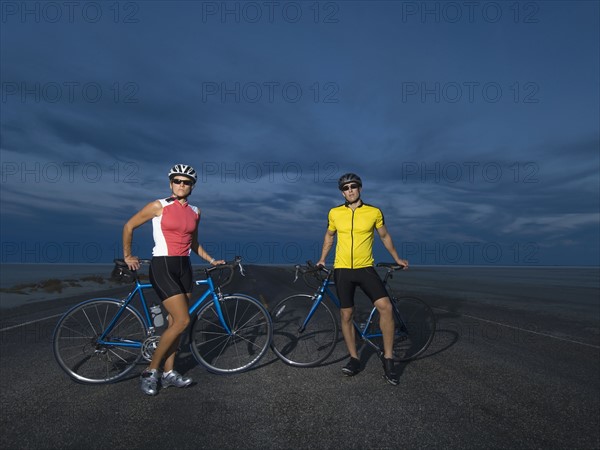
xmin=317 ymin=173 xmax=408 ymax=386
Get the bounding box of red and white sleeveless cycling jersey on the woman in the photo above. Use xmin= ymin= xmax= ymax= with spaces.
xmin=152 ymin=197 xmax=200 ymax=256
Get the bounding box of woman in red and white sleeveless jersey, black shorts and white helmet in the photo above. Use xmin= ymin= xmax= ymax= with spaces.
xmin=123 ymin=164 xmax=225 ymax=395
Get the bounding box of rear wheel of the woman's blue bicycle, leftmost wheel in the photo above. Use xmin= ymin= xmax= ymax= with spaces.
xmin=53 ymin=298 xmax=147 ymax=384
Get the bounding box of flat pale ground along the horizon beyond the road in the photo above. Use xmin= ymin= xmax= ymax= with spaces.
xmin=0 ymin=263 xmax=600 ymax=310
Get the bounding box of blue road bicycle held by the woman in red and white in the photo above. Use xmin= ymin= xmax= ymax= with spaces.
xmin=53 ymin=258 xmax=272 ymax=384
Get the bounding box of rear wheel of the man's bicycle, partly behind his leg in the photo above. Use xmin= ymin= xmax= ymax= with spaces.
xmin=368 ymin=297 xmax=435 ymax=361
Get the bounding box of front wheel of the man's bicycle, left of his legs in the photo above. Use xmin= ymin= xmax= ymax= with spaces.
xmin=271 ymin=294 xmax=338 ymax=367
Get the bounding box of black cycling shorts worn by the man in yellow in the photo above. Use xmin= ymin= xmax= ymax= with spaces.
xmin=333 ymin=267 xmax=388 ymax=308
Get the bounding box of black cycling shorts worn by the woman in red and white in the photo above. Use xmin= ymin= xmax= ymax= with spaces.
xmin=150 ymin=256 xmax=194 ymax=301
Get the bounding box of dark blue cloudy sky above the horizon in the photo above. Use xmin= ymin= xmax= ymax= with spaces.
xmin=0 ymin=1 xmax=600 ymax=265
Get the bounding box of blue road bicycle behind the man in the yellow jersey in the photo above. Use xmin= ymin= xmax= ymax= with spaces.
xmin=271 ymin=262 xmax=436 ymax=367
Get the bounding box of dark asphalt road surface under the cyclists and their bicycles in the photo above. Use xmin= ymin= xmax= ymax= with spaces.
xmin=0 ymin=266 xmax=600 ymax=449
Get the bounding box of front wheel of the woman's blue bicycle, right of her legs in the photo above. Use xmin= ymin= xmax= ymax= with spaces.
xmin=190 ymin=294 xmax=272 ymax=374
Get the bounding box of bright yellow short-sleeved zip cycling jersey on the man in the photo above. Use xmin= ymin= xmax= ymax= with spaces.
xmin=327 ymin=203 xmax=384 ymax=269
